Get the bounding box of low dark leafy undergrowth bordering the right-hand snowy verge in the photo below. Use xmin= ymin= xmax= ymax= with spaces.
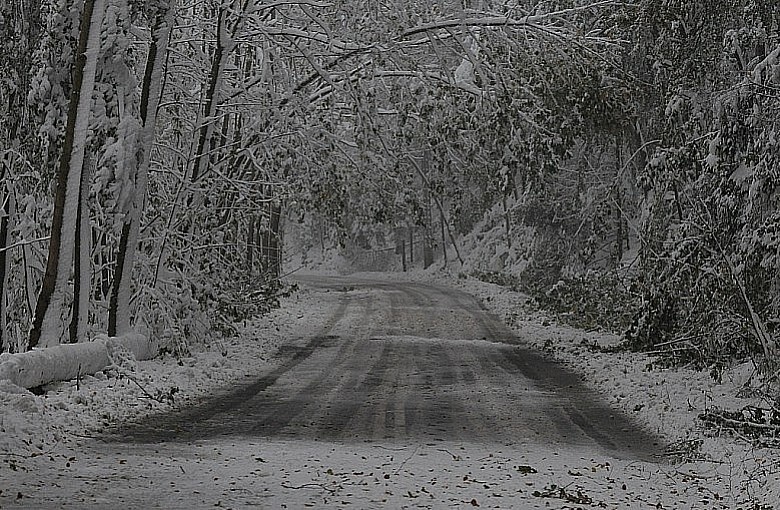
xmin=472 ymin=271 xmax=772 ymax=383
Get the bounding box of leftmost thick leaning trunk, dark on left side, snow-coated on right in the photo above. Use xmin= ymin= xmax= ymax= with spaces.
xmin=29 ymin=0 xmax=106 ymax=348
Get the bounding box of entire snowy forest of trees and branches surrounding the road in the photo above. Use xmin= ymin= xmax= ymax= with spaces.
xmin=0 ymin=0 xmax=780 ymax=380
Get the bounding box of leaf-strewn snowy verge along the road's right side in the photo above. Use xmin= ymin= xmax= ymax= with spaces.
xmin=438 ymin=275 xmax=780 ymax=509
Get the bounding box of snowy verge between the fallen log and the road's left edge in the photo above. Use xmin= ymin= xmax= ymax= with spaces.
xmin=0 ymin=290 xmax=332 ymax=458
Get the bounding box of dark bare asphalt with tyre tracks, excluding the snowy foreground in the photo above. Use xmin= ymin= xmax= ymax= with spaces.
xmin=105 ymin=277 xmax=662 ymax=459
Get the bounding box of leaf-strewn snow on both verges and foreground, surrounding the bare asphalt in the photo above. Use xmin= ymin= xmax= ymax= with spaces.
xmin=0 ymin=268 xmax=780 ymax=510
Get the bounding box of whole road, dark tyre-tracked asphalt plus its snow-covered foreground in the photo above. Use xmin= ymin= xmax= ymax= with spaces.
xmin=0 ymin=276 xmax=768 ymax=509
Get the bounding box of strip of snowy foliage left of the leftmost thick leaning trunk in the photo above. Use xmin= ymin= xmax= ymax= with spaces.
xmin=0 ymin=0 xmax=59 ymax=352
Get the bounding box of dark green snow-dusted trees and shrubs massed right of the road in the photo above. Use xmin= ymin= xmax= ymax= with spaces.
xmin=396 ymin=0 xmax=780 ymax=378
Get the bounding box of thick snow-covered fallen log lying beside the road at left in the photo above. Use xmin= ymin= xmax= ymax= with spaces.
xmin=0 ymin=333 xmax=159 ymax=388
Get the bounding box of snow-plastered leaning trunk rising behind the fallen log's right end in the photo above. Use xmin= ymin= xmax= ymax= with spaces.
xmin=108 ymin=0 xmax=176 ymax=336
